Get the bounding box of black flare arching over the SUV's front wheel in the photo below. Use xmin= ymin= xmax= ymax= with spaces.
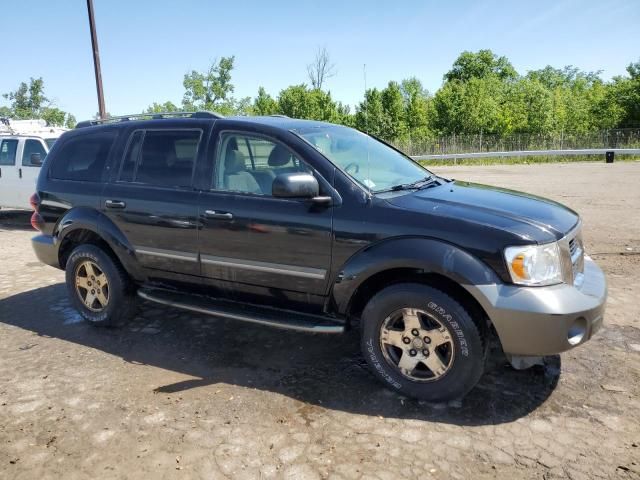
xmin=331 ymin=237 xmax=500 ymax=315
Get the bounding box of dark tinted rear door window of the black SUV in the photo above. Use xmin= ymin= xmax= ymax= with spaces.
xmin=119 ymin=130 xmax=202 ymax=187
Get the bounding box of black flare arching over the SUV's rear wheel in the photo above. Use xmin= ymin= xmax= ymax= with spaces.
xmin=53 ymin=207 xmax=145 ymax=281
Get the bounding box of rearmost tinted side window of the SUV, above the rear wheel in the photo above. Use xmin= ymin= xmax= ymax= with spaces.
xmin=51 ymin=131 xmax=116 ymax=182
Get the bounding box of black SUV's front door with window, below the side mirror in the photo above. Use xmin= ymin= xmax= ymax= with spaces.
xmin=198 ymin=131 xmax=333 ymax=303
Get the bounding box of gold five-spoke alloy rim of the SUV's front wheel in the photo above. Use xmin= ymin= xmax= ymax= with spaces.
xmin=380 ymin=308 xmax=454 ymax=382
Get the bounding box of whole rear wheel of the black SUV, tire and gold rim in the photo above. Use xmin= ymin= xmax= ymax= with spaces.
xmin=65 ymin=245 xmax=135 ymax=326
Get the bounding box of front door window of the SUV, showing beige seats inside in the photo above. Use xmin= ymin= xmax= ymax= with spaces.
xmin=213 ymin=133 xmax=311 ymax=195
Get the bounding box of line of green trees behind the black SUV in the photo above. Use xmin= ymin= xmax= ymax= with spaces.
xmin=0 ymin=48 xmax=640 ymax=146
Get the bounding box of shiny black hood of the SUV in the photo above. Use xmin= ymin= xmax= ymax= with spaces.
xmin=387 ymin=181 xmax=579 ymax=243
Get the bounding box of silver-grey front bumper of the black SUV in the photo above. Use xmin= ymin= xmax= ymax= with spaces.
xmin=468 ymin=257 xmax=607 ymax=356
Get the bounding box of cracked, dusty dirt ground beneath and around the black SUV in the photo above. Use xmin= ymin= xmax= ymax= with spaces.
xmin=0 ymin=162 xmax=640 ymax=480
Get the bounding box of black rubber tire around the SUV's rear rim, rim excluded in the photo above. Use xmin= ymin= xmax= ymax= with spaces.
xmin=65 ymin=245 xmax=136 ymax=327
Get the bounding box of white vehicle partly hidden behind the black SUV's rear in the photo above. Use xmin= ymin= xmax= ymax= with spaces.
xmin=0 ymin=119 xmax=66 ymax=209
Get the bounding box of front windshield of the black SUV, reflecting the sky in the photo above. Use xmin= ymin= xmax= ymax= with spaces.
xmin=294 ymin=125 xmax=430 ymax=193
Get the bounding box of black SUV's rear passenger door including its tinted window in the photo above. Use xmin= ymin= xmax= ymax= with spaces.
xmin=101 ymin=124 xmax=207 ymax=282
